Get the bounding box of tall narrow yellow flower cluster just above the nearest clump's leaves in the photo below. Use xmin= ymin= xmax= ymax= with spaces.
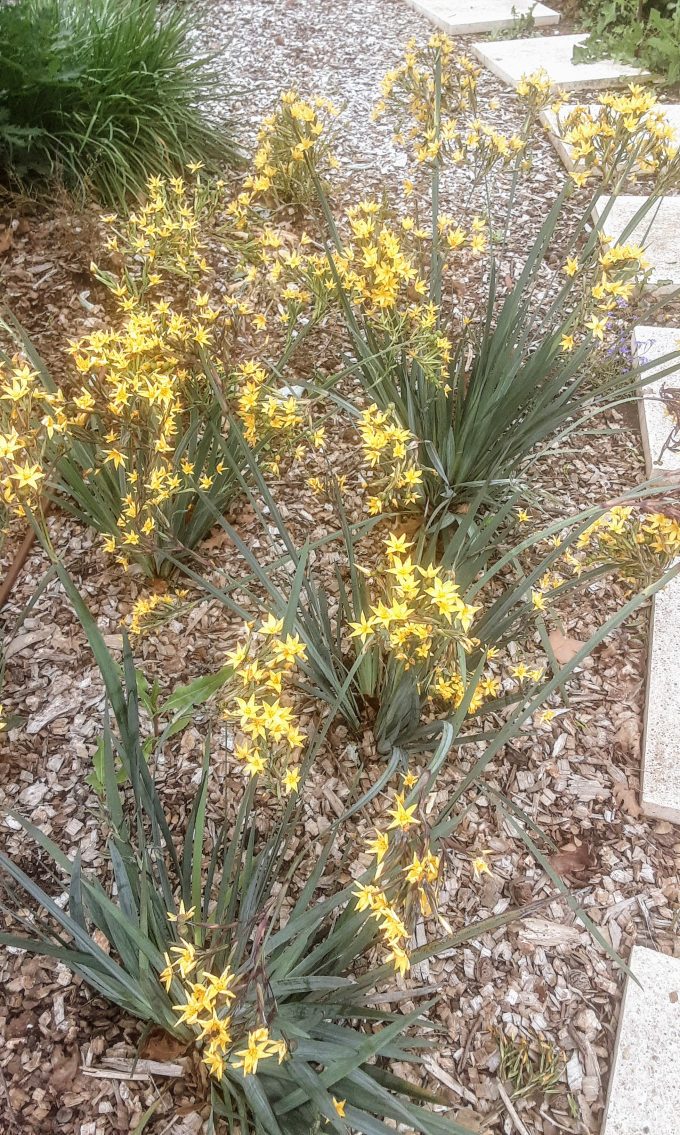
xmin=223 ymin=615 xmax=307 ymax=793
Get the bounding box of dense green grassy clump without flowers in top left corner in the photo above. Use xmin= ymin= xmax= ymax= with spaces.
xmin=0 ymin=0 xmax=236 ymax=204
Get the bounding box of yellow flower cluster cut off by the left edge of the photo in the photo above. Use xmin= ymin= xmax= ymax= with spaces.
xmin=0 ymin=355 xmax=68 ymax=516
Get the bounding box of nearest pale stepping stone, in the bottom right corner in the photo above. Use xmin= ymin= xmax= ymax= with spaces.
xmin=602 ymin=945 xmax=680 ymax=1135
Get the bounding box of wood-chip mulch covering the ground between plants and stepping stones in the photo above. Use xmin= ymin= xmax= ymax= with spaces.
xmin=0 ymin=0 xmax=680 ymax=1135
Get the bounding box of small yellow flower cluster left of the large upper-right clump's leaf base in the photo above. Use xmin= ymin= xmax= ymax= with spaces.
xmin=359 ymin=404 xmax=422 ymax=516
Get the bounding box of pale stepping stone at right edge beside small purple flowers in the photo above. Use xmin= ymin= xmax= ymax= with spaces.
xmin=632 ymin=327 xmax=680 ymax=476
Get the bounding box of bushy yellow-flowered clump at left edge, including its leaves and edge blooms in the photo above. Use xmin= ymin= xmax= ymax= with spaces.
xmin=1 ymin=304 xmax=245 ymax=575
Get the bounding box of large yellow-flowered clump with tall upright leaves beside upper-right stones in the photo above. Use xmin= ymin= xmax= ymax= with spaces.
xmin=280 ymin=34 xmax=680 ymax=522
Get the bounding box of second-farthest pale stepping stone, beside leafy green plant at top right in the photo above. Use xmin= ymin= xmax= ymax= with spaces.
xmin=472 ymin=35 xmax=647 ymax=91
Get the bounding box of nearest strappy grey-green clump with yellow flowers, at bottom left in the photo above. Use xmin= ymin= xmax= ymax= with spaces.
xmin=0 ymin=635 xmax=484 ymax=1135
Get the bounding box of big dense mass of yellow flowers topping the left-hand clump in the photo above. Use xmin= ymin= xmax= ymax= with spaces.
xmin=68 ymin=297 xmax=223 ymax=563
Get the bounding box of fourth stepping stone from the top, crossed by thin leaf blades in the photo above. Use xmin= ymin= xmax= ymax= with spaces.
xmin=593 ymin=194 xmax=680 ymax=294
